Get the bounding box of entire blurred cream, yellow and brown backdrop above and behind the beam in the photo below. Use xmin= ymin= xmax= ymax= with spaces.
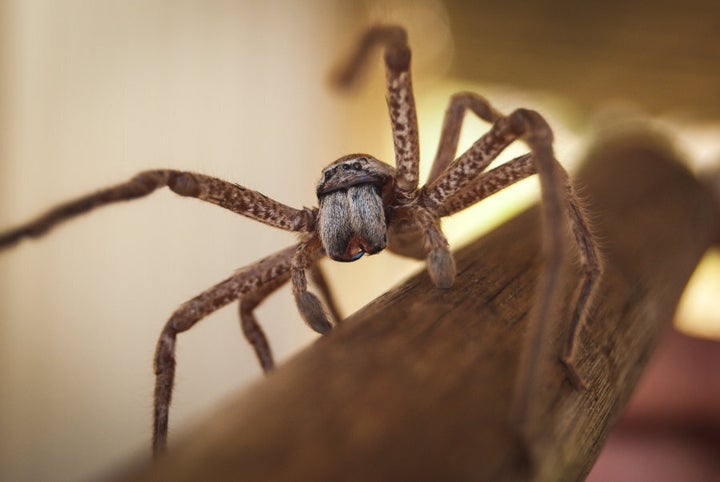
xmin=0 ymin=0 xmax=720 ymax=480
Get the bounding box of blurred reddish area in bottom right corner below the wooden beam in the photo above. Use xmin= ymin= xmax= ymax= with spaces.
xmin=587 ymin=331 xmax=720 ymax=482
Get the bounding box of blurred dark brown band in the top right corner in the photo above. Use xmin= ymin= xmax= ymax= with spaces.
xmin=446 ymin=0 xmax=720 ymax=119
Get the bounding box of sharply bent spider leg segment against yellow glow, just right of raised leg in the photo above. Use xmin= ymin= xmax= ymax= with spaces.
xmin=427 ymin=92 xmax=502 ymax=183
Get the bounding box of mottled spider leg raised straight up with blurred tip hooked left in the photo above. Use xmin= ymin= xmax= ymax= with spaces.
xmin=334 ymin=25 xmax=420 ymax=199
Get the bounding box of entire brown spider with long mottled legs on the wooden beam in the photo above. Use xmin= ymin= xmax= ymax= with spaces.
xmin=0 ymin=26 xmax=600 ymax=454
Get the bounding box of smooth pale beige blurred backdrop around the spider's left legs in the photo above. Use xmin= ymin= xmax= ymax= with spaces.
xmin=0 ymin=0 xmax=456 ymax=480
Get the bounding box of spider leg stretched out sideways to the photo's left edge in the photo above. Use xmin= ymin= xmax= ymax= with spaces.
xmin=0 ymin=169 xmax=316 ymax=249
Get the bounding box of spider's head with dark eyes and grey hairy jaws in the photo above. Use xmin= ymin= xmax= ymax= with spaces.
xmin=317 ymin=154 xmax=394 ymax=261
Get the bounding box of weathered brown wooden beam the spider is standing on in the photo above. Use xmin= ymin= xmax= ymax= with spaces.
xmin=111 ymin=133 xmax=717 ymax=481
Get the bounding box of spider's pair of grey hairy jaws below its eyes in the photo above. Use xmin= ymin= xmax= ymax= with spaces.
xmin=318 ymin=184 xmax=387 ymax=261
